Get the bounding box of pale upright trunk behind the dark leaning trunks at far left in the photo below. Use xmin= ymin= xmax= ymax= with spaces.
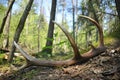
xmin=3 ymin=0 xmax=11 ymax=49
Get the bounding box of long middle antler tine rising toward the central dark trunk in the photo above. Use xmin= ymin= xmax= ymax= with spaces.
xmin=52 ymin=21 xmax=81 ymax=59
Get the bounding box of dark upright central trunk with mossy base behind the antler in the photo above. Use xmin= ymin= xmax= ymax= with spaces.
xmin=43 ymin=0 xmax=57 ymax=56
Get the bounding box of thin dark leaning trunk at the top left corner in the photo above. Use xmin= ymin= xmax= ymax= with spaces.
xmin=0 ymin=0 xmax=15 ymax=34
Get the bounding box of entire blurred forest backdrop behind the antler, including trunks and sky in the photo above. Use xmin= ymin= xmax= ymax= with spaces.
xmin=0 ymin=0 xmax=120 ymax=79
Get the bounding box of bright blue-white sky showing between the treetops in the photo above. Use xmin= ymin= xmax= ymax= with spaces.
xmin=0 ymin=0 xmax=81 ymax=29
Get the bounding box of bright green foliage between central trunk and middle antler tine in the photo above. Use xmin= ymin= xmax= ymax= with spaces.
xmin=53 ymin=23 xmax=71 ymax=53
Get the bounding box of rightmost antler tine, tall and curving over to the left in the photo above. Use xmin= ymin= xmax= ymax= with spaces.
xmin=80 ymin=15 xmax=104 ymax=46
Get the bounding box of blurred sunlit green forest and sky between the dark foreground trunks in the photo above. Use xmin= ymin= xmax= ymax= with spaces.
xmin=0 ymin=0 xmax=120 ymax=53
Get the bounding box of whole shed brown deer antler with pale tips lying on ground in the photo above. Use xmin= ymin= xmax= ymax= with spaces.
xmin=14 ymin=15 xmax=106 ymax=69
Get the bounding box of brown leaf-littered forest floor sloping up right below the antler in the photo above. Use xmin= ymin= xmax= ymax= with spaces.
xmin=0 ymin=47 xmax=120 ymax=80
